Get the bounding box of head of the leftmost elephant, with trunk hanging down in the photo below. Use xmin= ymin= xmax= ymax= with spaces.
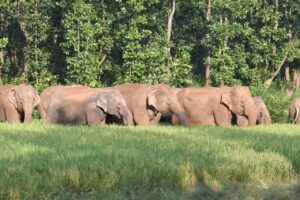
xmin=8 ymin=84 xmax=40 ymax=123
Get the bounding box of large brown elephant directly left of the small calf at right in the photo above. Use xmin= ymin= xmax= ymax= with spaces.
xmin=172 ymin=86 xmax=256 ymax=126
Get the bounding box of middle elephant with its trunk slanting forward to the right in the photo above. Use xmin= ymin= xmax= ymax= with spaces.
xmin=113 ymin=83 xmax=188 ymax=126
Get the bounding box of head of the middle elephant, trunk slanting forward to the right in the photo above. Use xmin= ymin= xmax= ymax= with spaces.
xmin=147 ymin=85 xmax=188 ymax=126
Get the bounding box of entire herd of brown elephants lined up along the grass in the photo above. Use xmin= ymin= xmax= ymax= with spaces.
xmin=0 ymin=84 xmax=300 ymax=126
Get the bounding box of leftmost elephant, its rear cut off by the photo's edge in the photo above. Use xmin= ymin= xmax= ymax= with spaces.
xmin=0 ymin=84 xmax=40 ymax=123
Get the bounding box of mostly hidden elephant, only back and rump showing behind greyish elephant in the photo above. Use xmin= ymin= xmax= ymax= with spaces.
xmin=38 ymin=85 xmax=83 ymax=120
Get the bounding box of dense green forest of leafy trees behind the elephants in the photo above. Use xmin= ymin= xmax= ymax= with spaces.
xmin=0 ymin=0 xmax=300 ymax=95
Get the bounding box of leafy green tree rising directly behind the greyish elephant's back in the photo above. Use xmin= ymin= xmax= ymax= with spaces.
xmin=62 ymin=0 xmax=103 ymax=86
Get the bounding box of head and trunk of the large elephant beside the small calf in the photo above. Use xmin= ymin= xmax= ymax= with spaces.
xmin=221 ymin=86 xmax=257 ymax=126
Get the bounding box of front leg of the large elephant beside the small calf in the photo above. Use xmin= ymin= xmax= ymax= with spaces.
xmin=214 ymin=105 xmax=232 ymax=126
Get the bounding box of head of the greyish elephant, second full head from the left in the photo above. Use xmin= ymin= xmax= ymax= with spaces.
xmin=96 ymin=91 xmax=133 ymax=125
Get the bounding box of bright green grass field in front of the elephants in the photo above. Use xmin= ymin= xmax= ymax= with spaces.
xmin=0 ymin=121 xmax=300 ymax=199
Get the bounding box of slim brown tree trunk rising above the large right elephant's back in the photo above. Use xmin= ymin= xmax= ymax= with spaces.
xmin=205 ymin=0 xmax=211 ymax=86
